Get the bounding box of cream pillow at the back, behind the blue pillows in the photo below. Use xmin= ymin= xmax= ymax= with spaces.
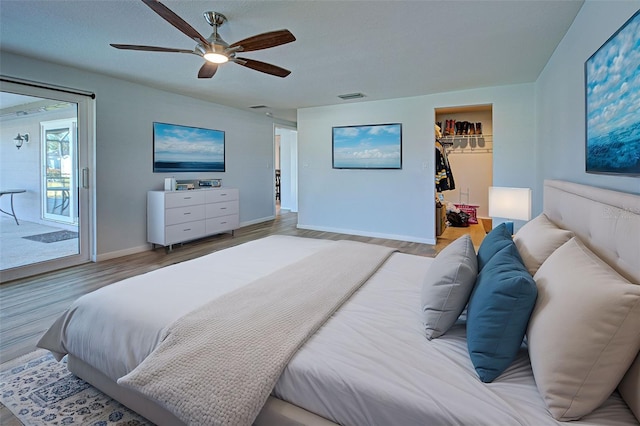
xmin=513 ymin=213 xmax=573 ymax=275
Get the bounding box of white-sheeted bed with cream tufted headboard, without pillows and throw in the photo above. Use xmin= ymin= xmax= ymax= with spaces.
xmin=39 ymin=181 xmax=640 ymax=425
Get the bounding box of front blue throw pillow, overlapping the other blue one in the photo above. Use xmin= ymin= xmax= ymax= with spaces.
xmin=467 ymin=242 xmax=538 ymax=383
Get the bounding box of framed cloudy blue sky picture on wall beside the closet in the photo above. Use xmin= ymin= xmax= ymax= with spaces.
xmin=333 ymin=123 xmax=402 ymax=169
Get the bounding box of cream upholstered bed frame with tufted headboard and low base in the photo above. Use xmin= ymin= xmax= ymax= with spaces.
xmin=68 ymin=181 xmax=640 ymax=426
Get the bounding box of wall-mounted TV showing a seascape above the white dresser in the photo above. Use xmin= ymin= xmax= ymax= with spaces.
xmin=153 ymin=122 xmax=225 ymax=173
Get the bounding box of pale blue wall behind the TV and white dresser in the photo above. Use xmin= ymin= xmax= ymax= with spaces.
xmin=0 ymin=52 xmax=275 ymax=259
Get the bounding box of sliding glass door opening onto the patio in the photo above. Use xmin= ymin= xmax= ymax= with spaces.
xmin=0 ymin=81 xmax=94 ymax=282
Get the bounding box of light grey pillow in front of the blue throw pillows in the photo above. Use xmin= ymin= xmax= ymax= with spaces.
xmin=422 ymin=234 xmax=478 ymax=340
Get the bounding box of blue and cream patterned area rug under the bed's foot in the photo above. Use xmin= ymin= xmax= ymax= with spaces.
xmin=0 ymin=349 xmax=153 ymax=426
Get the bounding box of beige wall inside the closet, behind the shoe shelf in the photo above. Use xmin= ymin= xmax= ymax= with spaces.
xmin=435 ymin=105 xmax=493 ymax=218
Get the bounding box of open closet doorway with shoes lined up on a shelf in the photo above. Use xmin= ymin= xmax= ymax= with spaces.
xmin=435 ymin=104 xmax=493 ymax=245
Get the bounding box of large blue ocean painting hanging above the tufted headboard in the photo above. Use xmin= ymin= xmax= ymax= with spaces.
xmin=585 ymin=12 xmax=640 ymax=175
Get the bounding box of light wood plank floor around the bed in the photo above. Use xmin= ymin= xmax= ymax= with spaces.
xmin=0 ymin=211 xmax=484 ymax=425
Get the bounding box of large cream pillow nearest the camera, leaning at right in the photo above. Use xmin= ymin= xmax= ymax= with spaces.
xmin=527 ymin=237 xmax=640 ymax=421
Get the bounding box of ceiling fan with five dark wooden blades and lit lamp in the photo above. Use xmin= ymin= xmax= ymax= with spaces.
xmin=111 ymin=0 xmax=296 ymax=78
